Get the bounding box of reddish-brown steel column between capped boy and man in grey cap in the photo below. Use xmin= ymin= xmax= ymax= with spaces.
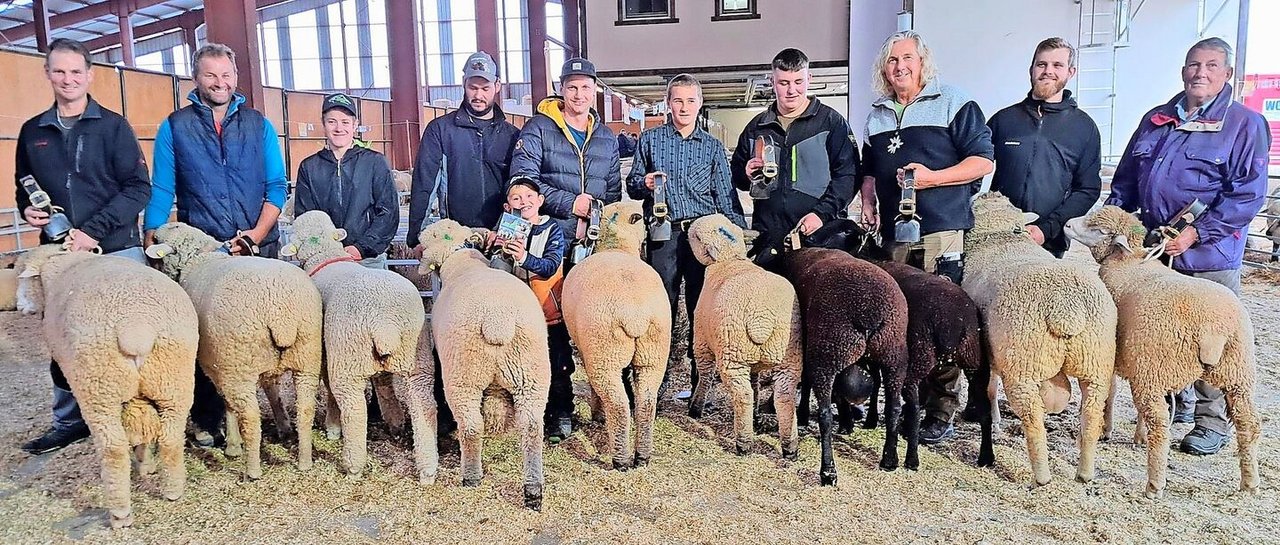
xmin=384 ymin=1 xmax=422 ymax=169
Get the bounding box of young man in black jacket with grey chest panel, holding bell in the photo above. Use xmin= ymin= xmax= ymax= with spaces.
xmin=730 ymin=49 xmax=858 ymax=255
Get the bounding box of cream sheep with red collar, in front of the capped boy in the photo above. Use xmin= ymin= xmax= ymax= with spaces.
xmin=280 ymin=210 xmax=438 ymax=484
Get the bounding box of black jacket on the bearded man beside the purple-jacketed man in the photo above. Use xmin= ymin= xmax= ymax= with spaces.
xmin=988 ymin=91 xmax=1102 ymax=253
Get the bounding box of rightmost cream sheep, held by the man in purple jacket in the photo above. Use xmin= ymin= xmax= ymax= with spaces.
xmin=1066 ymin=206 xmax=1258 ymax=498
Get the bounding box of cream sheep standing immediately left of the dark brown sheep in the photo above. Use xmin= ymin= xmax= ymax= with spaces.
xmin=689 ymin=214 xmax=803 ymax=459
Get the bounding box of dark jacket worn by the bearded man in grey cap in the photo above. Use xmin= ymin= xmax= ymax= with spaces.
xmin=407 ymin=106 xmax=520 ymax=248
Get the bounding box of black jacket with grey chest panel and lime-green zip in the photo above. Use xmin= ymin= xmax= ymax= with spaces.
xmin=730 ymin=99 xmax=858 ymax=248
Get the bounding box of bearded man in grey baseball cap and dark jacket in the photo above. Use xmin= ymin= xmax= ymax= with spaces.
xmin=407 ymin=51 xmax=520 ymax=247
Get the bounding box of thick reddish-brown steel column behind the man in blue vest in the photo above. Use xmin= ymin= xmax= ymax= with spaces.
xmin=203 ymin=0 xmax=264 ymax=110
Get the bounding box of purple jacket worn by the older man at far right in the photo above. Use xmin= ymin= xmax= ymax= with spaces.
xmin=1107 ymin=86 xmax=1271 ymax=273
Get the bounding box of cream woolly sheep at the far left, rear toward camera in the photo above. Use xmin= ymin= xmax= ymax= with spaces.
xmin=17 ymin=246 xmax=198 ymax=528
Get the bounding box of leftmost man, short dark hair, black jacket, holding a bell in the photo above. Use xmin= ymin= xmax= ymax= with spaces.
xmin=15 ymin=38 xmax=151 ymax=454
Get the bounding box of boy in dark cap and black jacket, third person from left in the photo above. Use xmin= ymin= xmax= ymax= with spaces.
xmin=293 ymin=93 xmax=399 ymax=269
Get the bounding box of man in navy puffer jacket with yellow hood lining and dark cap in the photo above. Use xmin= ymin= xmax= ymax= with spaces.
xmin=511 ymin=58 xmax=622 ymax=438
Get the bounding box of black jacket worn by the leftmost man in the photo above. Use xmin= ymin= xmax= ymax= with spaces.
xmin=14 ymin=97 xmax=151 ymax=253
